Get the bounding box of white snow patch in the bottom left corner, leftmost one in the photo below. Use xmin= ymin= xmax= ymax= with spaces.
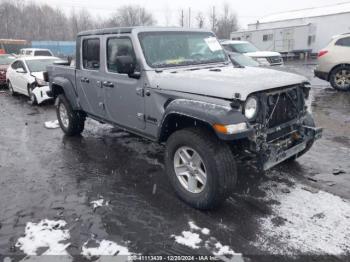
xmin=16 ymin=219 xmax=70 ymax=256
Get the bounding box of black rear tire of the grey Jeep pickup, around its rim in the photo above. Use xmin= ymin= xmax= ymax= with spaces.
xmin=56 ymin=94 xmax=86 ymax=136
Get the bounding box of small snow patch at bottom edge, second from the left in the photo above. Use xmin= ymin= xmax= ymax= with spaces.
xmin=81 ymin=240 xmax=131 ymax=259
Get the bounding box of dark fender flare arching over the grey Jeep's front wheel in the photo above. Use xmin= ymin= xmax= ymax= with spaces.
xmin=158 ymin=99 xmax=252 ymax=140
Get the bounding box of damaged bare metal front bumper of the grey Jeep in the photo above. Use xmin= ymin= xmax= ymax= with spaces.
xmin=261 ymin=125 xmax=323 ymax=171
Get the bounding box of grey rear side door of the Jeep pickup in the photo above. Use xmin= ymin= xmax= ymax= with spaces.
xmin=76 ymin=36 xmax=105 ymax=118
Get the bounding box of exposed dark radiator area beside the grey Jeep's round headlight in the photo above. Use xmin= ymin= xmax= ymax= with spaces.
xmin=266 ymin=88 xmax=300 ymax=128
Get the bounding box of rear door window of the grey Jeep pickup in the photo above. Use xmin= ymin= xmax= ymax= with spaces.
xmin=82 ymin=38 xmax=100 ymax=70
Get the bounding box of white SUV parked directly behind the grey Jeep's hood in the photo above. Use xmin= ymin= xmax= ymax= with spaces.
xmin=221 ymin=40 xmax=284 ymax=66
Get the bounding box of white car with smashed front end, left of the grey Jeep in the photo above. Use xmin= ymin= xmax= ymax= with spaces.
xmin=6 ymin=56 xmax=60 ymax=104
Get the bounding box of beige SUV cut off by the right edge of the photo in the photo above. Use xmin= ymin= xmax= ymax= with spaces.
xmin=315 ymin=33 xmax=350 ymax=91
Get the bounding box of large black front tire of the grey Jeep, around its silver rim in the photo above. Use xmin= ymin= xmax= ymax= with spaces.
xmin=165 ymin=128 xmax=237 ymax=210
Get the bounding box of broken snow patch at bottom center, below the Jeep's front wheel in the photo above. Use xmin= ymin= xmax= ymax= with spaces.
xmin=171 ymin=221 xmax=244 ymax=262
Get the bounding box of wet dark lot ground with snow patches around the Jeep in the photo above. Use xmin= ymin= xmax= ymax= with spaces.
xmin=0 ymin=62 xmax=350 ymax=262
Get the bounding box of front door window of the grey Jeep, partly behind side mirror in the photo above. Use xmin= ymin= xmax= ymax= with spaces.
xmin=107 ymin=38 xmax=135 ymax=73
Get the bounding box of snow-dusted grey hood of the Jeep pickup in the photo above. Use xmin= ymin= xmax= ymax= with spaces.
xmin=149 ymin=66 xmax=308 ymax=101
